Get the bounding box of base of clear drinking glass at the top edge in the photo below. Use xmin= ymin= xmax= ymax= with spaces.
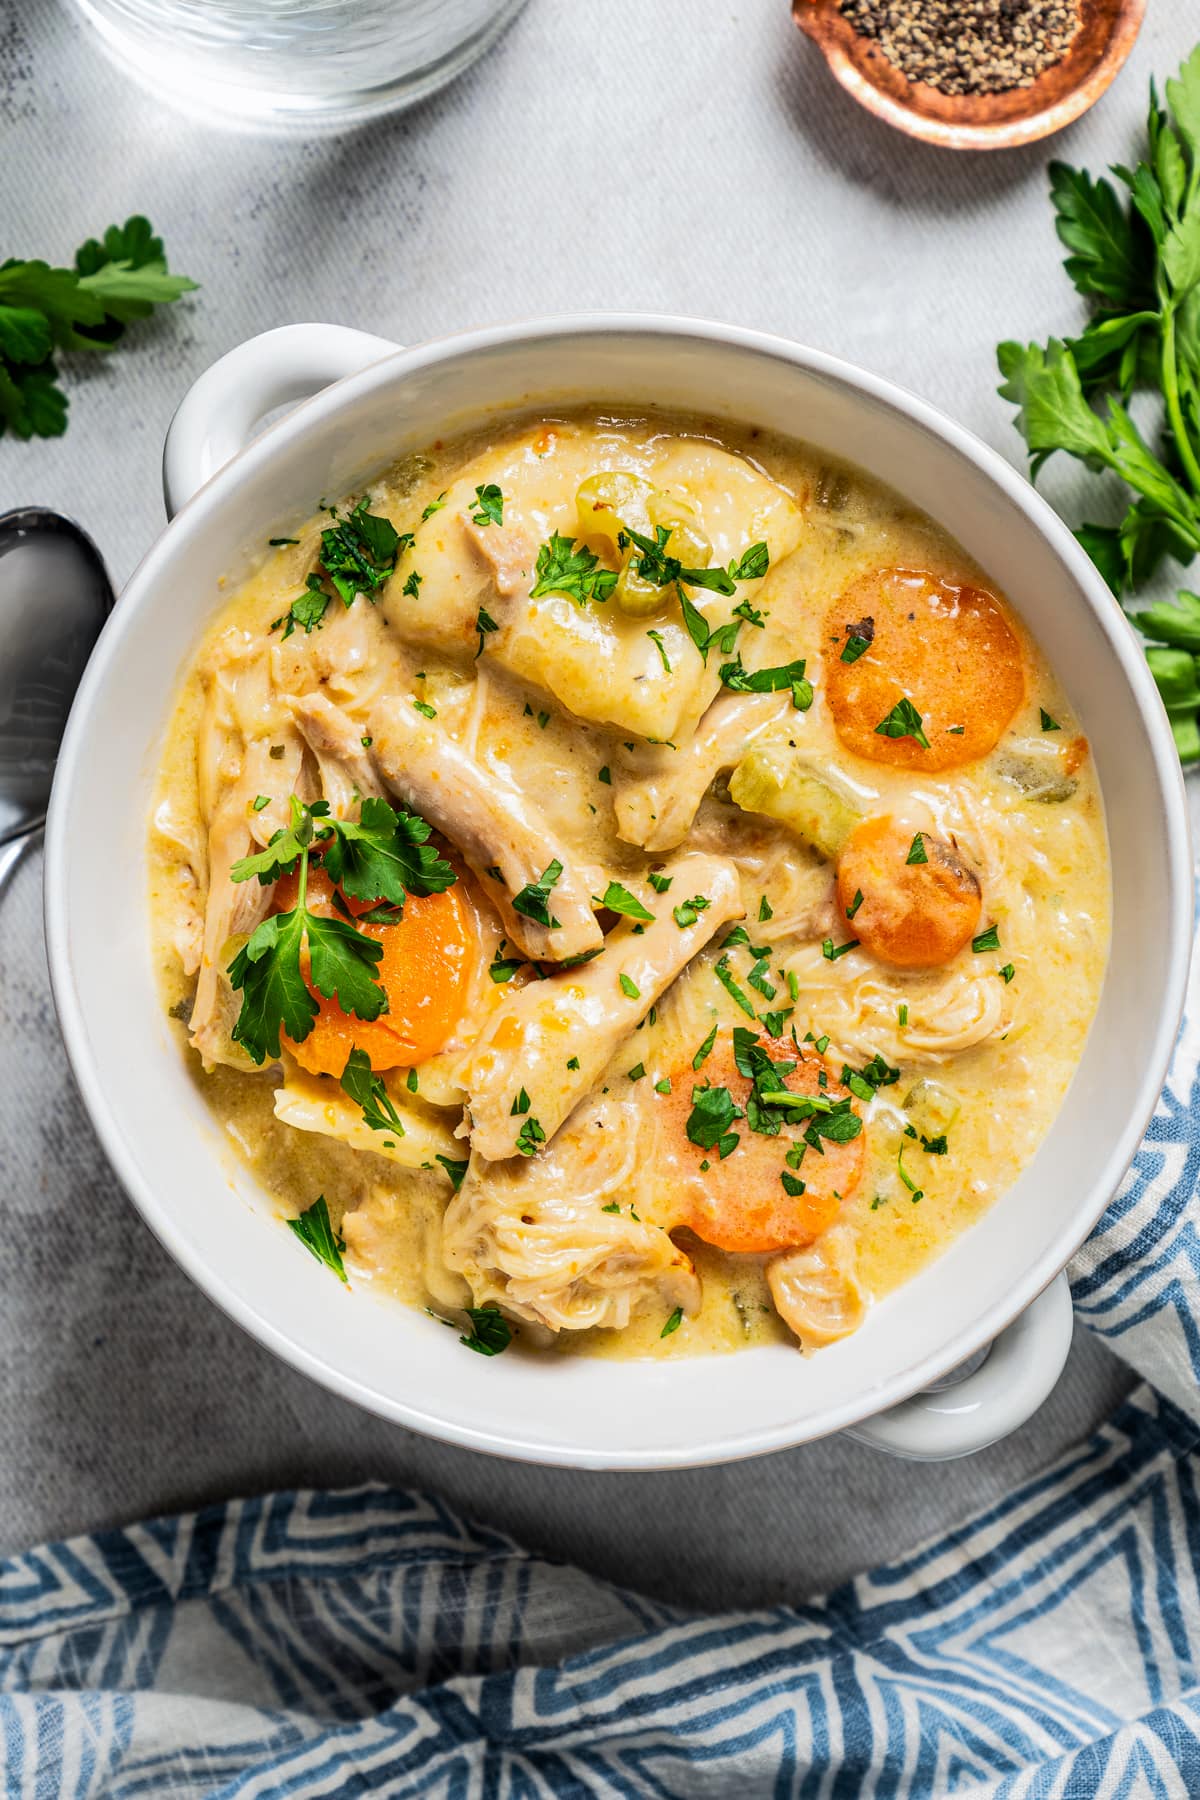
xmin=67 ymin=0 xmax=525 ymax=131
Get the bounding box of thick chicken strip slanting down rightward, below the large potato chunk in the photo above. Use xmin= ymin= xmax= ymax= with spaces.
xmin=371 ymin=698 xmax=604 ymax=963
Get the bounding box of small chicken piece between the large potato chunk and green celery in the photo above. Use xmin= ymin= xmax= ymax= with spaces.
xmin=613 ymin=693 xmax=792 ymax=850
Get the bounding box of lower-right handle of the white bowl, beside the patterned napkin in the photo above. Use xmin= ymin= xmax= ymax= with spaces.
xmin=846 ymin=1273 xmax=1074 ymax=1462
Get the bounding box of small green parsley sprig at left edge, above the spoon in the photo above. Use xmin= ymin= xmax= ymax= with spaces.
xmin=0 ymin=214 xmax=196 ymax=437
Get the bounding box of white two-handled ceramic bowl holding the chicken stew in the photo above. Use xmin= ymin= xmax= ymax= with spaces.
xmin=47 ymin=317 xmax=1191 ymax=1469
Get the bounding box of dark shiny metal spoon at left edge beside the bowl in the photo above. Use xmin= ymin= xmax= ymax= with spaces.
xmin=0 ymin=506 xmax=113 ymax=895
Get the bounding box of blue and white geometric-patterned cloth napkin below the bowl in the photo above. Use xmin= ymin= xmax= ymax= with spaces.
xmin=0 ymin=950 xmax=1200 ymax=1800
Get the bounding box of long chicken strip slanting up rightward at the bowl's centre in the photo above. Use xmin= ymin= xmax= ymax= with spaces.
xmin=462 ymin=857 xmax=745 ymax=1159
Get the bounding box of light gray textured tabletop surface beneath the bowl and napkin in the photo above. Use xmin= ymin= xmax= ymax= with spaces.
xmin=0 ymin=0 xmax=1196 ymax=1604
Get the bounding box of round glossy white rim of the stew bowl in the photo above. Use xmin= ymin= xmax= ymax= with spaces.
xmin=43 ymin=311 xmax=1193 ymax=1469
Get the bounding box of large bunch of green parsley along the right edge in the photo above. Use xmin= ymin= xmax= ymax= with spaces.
xmin=997 ymin=45 xmax=1200 ymax=763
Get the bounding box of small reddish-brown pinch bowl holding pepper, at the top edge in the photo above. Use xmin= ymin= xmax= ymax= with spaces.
xmin=792 ymin=0 xmax=1146 ymax=149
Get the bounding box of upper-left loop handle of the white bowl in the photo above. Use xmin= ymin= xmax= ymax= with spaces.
xmin=162 ymin=324 xmax=399 ymax=518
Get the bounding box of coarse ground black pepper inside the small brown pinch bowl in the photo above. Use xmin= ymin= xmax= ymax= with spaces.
xmin=838 ymin=0 xmax=1079 ymax=94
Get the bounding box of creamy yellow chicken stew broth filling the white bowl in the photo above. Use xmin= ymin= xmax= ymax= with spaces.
xmin=149 ymin=412 xmax=1108 ymax=1355
